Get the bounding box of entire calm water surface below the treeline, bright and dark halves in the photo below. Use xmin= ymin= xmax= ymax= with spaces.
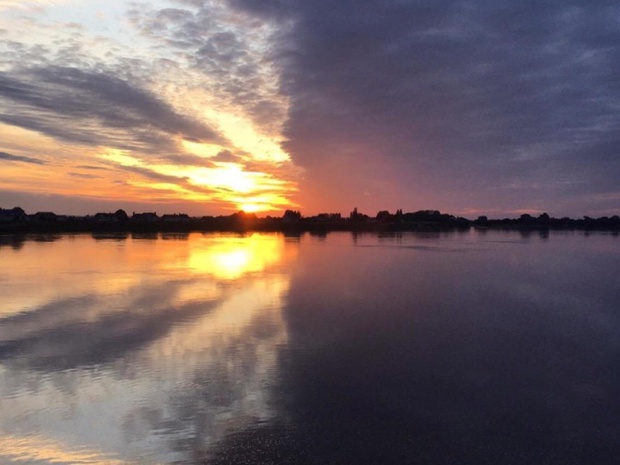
xmin=0 ymin=232 xmax=620 ymax=465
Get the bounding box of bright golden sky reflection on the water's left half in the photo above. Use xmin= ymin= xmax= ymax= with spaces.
xmin=0 ymin=235 xmax=297 ymax=464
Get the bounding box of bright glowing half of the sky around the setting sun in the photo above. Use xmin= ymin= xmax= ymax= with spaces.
xmin=0 ymin=0 xmax=299 ymax=215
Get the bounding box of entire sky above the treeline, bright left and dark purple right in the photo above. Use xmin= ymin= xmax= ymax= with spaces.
xmin=0 ymin=0 xmax=620 ymax=218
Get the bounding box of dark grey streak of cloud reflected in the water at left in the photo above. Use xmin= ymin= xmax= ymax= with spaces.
xmin=0 ymin=283 xmax=217 ymax=372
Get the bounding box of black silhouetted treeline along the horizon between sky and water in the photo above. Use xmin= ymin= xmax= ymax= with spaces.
xmin=0 ymin=207 xmax=620 ymax=233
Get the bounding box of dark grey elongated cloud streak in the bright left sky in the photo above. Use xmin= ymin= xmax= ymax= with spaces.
xmin=0 ymin=67 xmax=222 ymax=149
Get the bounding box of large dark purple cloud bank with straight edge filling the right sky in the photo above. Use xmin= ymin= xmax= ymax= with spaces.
xmin=232 ymin=0 xmax=620 ymax=214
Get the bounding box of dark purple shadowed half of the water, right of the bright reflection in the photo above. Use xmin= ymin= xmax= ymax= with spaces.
xmin=203 ymin=233 xmax=620 ymax=465
